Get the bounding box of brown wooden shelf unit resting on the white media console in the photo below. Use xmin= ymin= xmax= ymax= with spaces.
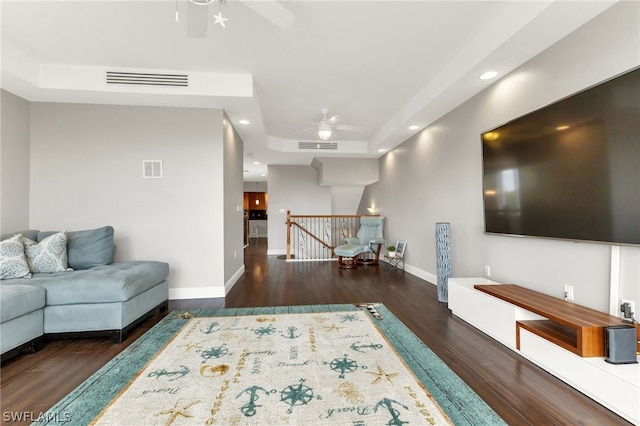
xmin=474 ymin=284 xmax=622 ymax=357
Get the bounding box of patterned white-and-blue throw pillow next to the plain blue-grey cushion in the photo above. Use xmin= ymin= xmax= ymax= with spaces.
xmin=22 ymin=232 xmax=68 ymax=274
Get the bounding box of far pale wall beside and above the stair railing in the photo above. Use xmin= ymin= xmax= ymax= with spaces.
xmin=267 ymin=165 xmax=331 ymax=254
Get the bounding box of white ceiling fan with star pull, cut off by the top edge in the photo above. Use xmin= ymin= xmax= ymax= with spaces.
xmin=184 ymin=0 xmax=296 ymax=38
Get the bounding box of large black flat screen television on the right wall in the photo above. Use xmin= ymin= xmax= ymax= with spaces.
xmin=481 ymin=68 xmax=640 ymax=245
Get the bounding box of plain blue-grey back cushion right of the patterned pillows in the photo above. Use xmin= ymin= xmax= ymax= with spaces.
xmin=38 ymin=226 xmax=114 ymax=269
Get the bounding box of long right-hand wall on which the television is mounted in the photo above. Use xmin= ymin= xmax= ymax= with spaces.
xmin=359 ymin=2 xmax=640 ymax=311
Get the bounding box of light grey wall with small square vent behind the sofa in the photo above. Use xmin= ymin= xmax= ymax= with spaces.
xmin=30 ymin=103 xmax=232 ymax=298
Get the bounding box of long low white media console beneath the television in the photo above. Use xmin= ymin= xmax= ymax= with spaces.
xmin=448 ymin=278 xmax=640 ymax=424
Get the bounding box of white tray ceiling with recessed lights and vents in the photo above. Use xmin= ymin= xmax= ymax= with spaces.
xmin=1 ymin=0 xmax=615 ymax=181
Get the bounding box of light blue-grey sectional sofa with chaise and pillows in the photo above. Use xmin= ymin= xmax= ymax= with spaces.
xmin=0 ymin=226 xmax=169 ymax=360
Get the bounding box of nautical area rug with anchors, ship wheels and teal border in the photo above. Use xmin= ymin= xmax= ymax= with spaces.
xmin=36 ymin=304 xmax=504 ymax=425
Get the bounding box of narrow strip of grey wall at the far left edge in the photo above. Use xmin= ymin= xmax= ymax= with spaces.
xmin=0 ymin=90 xmax=29 ymax=234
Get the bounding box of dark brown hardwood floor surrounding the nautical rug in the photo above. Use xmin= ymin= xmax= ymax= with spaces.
xmin=0 ymin=239 xmax=630 ymax=425
